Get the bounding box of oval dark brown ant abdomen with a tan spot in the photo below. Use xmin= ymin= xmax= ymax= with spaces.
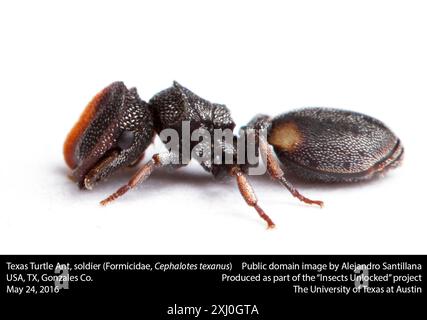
xmin=268 ymin=108 xmax=403 ymax=182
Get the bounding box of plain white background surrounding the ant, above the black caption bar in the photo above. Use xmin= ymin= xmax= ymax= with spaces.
xmin=0 ymin=0 xmax=427 ymax=254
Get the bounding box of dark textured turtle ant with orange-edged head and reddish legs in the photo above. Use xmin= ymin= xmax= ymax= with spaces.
xmin=64 ymin=82 xmax=403 ymax=228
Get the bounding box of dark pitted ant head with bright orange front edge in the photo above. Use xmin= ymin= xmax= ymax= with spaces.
xmin=64 ymin=82 xmax=154 ymax=189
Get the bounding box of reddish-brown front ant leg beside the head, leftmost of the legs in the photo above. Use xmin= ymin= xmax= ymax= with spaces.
xmin=100 ymin=153 xmax=165 ymax=206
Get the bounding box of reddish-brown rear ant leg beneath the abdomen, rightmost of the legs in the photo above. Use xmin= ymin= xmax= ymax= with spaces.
xmin=259 ymin=136 xmax=323 ymax=207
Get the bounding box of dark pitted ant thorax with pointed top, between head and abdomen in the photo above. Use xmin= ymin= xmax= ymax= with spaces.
xmin=149 ymin=82 xmax=259 ymax=178
